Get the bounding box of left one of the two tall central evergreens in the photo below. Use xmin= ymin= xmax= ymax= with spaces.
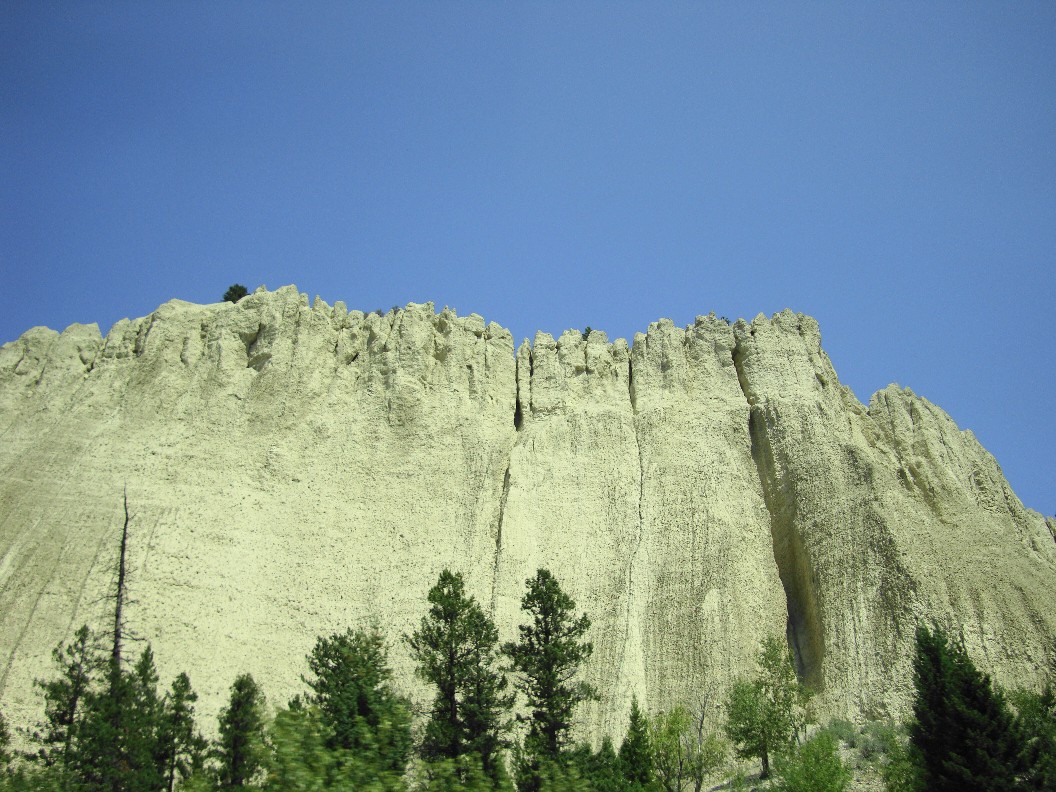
xmin=408 ymin=569 xmax=514 ymax=779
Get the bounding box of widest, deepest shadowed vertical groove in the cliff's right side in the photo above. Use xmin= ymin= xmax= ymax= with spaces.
xmin=733 ymin=344 xmax=825 ymax=692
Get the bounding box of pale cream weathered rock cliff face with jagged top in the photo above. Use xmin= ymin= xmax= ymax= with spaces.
xmin=0 ymin=286 xmax=1056 ymax=736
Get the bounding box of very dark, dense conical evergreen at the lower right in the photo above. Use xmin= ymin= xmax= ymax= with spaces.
xmin=909 ymin=625 xmax=1022 ymax=792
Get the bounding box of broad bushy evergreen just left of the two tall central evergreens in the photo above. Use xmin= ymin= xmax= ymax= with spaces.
xmin=304 ymin=626 xmax=412 ymax=775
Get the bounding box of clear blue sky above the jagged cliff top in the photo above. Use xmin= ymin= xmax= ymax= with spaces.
xmin=0 ymin=0 xmax=1056 ymax=514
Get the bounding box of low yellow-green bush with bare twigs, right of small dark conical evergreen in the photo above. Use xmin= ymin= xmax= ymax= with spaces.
xmin=650 ymin=705 xmax=729 ymax=792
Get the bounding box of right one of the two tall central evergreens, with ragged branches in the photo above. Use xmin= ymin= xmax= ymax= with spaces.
xmin=503 ymin=569 xmax=597 ymax=792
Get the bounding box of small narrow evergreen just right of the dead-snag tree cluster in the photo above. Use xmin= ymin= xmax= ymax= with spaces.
xmin=216 ymin=674 xmax=265 ymax=789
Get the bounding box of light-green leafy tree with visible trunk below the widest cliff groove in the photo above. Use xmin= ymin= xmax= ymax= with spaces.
xmin=724 ymin=636 xmax=811 ymax=778
